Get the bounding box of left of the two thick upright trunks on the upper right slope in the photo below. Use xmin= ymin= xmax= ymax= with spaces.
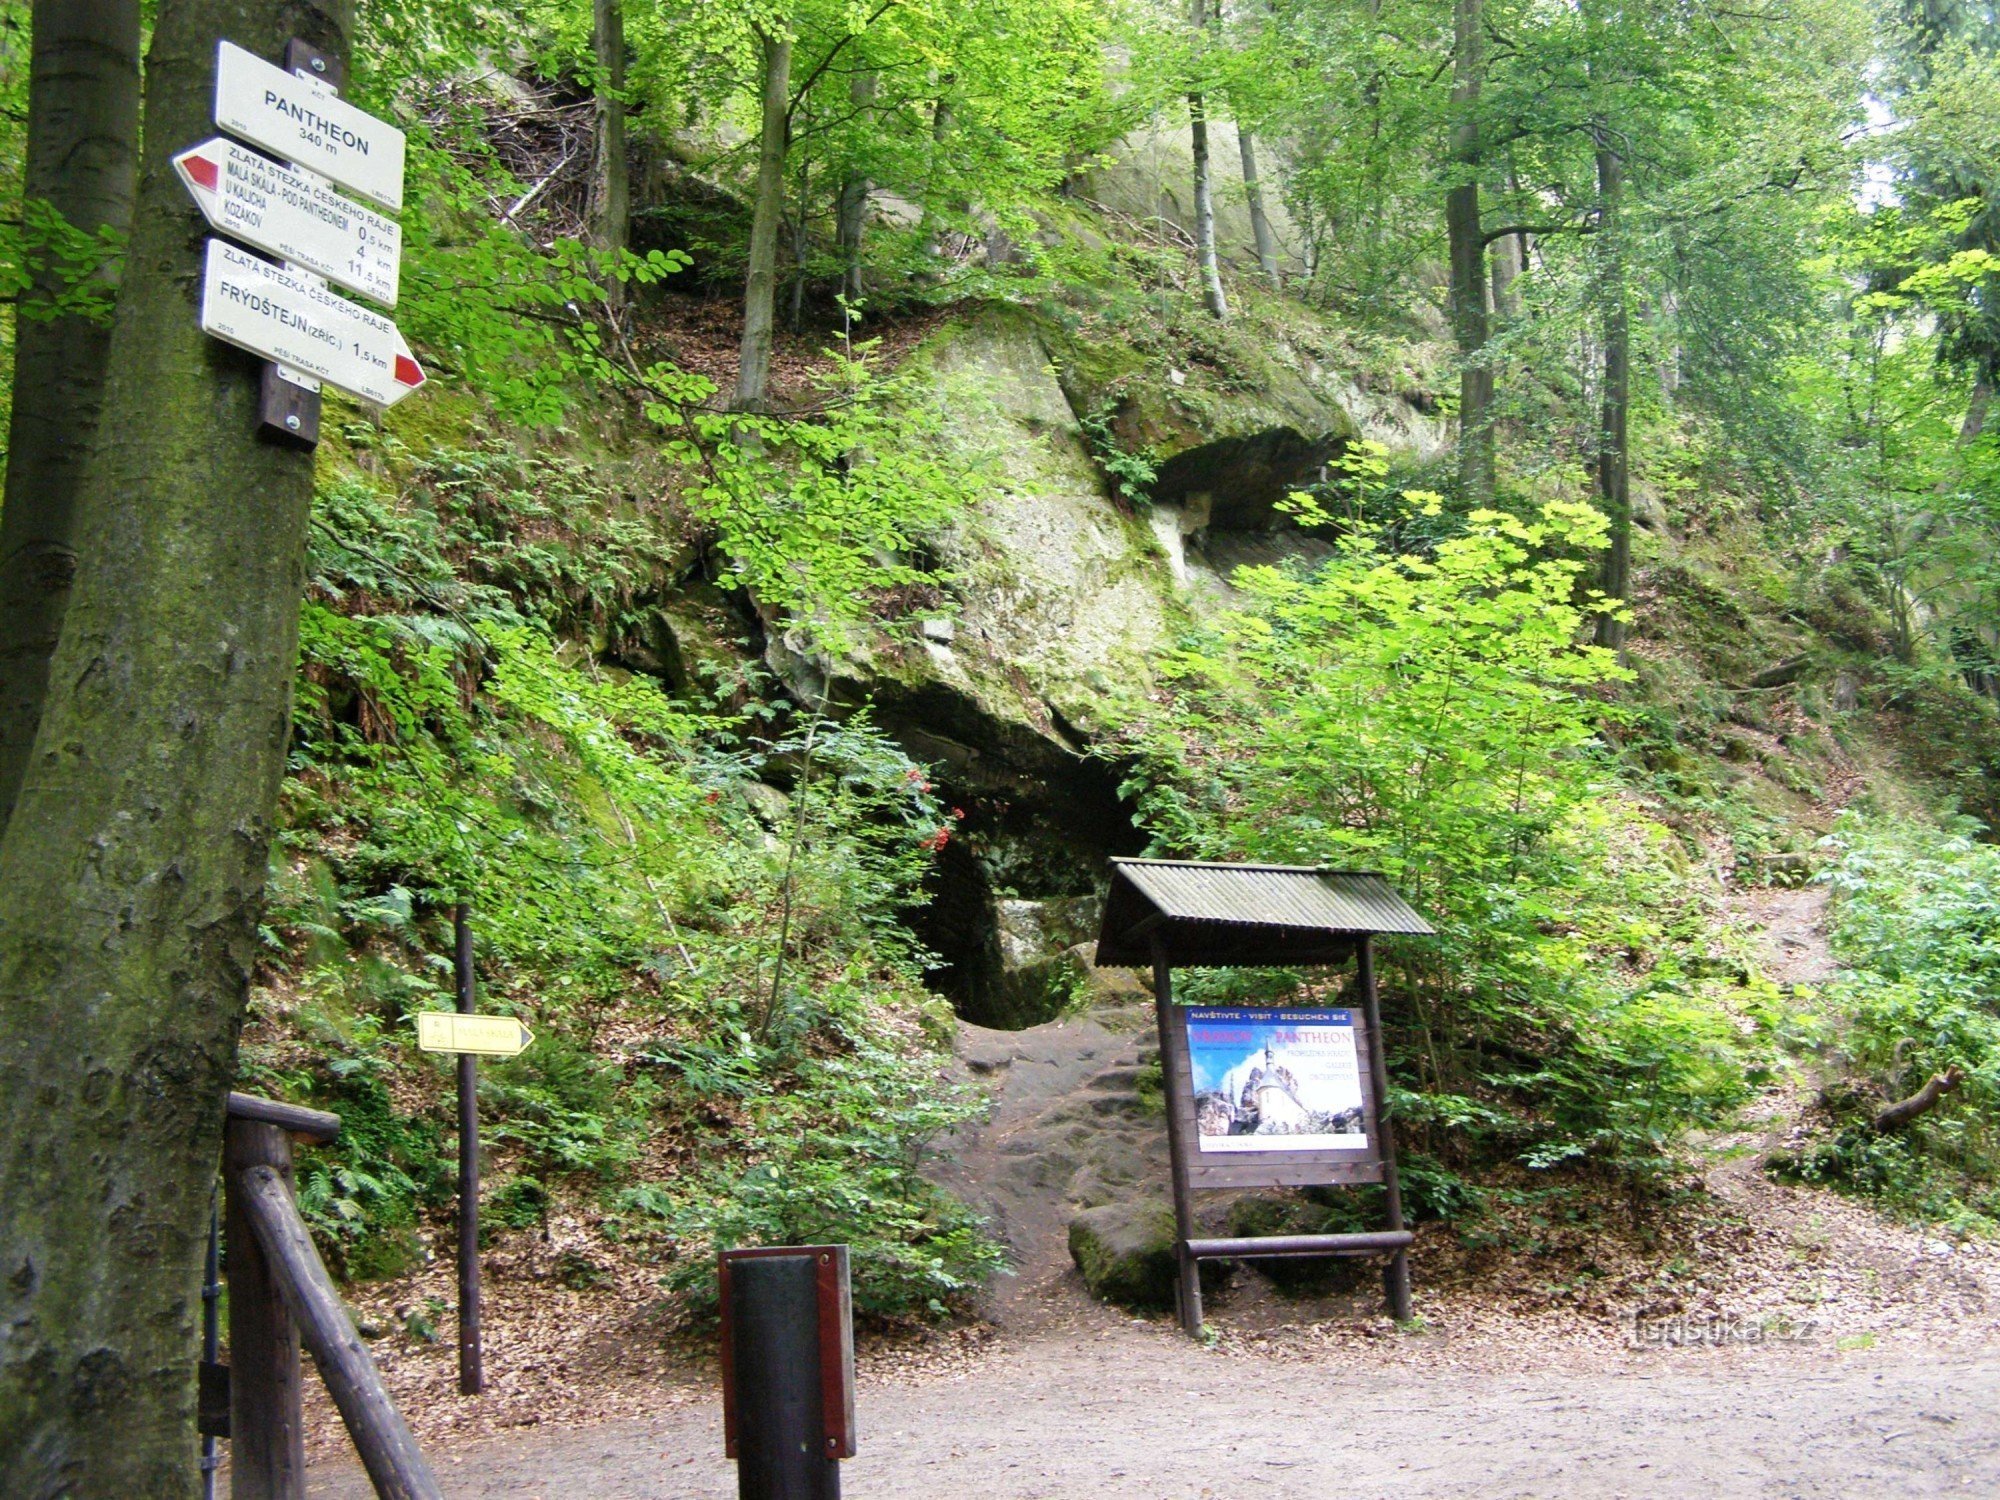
xmin=1444 ymin=0 xmax=1494 ymax=506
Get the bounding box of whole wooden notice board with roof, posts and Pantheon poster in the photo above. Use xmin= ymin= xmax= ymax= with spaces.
xmin=1096 ymin=860 xmax=1432 ymax=1336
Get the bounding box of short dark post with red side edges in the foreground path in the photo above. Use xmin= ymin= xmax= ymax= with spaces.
xmin=728 ymin=1254 xmax=840 ymax=1500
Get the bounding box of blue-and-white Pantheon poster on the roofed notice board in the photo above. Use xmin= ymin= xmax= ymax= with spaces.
xmin=1186 ymin=1006 xmax=1368 ymax=1152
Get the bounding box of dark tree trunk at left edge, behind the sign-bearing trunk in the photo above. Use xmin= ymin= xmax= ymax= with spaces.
xmin=0 ymin=0 xmax=138 ymax=826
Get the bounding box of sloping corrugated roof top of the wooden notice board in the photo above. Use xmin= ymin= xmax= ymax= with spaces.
xmin=1106 ymin=860 xmax=1434 ymax=932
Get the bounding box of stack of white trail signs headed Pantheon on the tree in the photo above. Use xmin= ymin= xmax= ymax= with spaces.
xmin=174 ymin=40 xmax=424 ymax=446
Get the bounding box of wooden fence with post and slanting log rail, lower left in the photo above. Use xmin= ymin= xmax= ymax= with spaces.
xmin=224 ymin=1094 xmax=444 ymax=1500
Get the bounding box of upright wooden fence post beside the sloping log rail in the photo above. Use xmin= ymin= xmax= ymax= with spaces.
xmin=224 ymin=1118 xmax=306 ymax=1500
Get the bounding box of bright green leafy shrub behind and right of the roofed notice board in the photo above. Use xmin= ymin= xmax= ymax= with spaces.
xmin=1134 ymin=504 xmax=1746 ymax=1208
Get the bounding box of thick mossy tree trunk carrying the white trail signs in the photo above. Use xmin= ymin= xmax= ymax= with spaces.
xmin=0 ymin=0 xmax=352 ymax=1500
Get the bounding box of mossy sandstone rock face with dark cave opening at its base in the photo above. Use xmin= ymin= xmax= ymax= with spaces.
xmin=788 ymin=306 xmax=1442 ymax=1028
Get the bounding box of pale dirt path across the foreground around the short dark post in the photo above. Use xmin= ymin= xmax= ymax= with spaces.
xmin=300 ymin=1318 xmax=2000 ymax=1500
